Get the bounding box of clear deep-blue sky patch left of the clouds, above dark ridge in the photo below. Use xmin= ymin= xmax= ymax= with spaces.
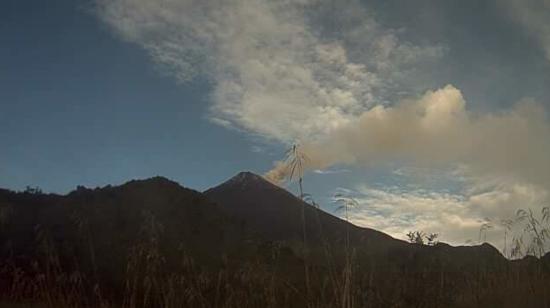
xmin=0 ymin=1 xmax=282 ymax=193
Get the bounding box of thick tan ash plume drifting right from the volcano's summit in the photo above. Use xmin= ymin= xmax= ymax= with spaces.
xmin=294 ymin=85 xmax=550 ymax=187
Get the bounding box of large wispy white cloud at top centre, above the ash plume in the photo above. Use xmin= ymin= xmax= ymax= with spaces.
xmin=97 ymin=0 xmax=442 ymax=142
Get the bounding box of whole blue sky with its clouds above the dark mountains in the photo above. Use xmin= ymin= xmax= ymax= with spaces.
xmin=0 ymin=0 xmax=550 ymax=247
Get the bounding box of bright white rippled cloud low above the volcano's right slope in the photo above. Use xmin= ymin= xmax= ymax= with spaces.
xmin=351 ymin=179 xmax=548 ymax=249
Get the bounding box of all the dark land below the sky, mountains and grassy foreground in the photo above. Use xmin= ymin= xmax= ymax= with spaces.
xmin=0 ymin=173 xmax=550 ymax=307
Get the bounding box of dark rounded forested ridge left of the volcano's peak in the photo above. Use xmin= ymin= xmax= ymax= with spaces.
xmin=0 ymin=177 xmax=246 ymax=258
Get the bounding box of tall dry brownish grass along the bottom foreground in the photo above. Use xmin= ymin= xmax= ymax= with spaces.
xmin=0 ymin=201 xmax=550 ymax=308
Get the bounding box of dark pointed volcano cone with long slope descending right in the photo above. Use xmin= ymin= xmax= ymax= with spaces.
xmin=204 ymin=172 xmax=505 ymax=264
